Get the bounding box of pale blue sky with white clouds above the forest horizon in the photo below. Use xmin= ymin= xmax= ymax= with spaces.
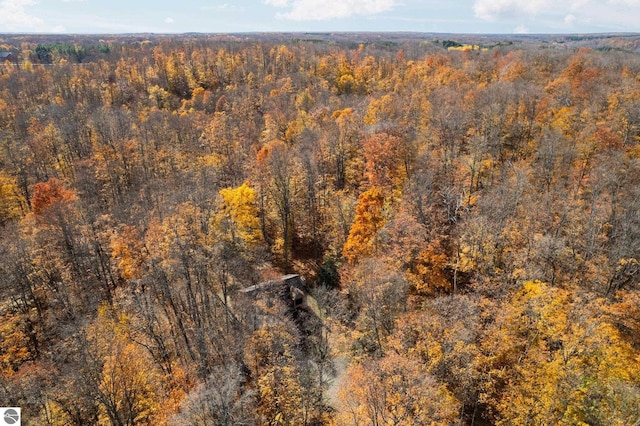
xmin=0 ymin=0 xmax=640 ymax=34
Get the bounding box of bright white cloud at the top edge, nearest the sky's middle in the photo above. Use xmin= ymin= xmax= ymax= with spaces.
xmin=264 ymin=0 xmax=397 ymax=21
